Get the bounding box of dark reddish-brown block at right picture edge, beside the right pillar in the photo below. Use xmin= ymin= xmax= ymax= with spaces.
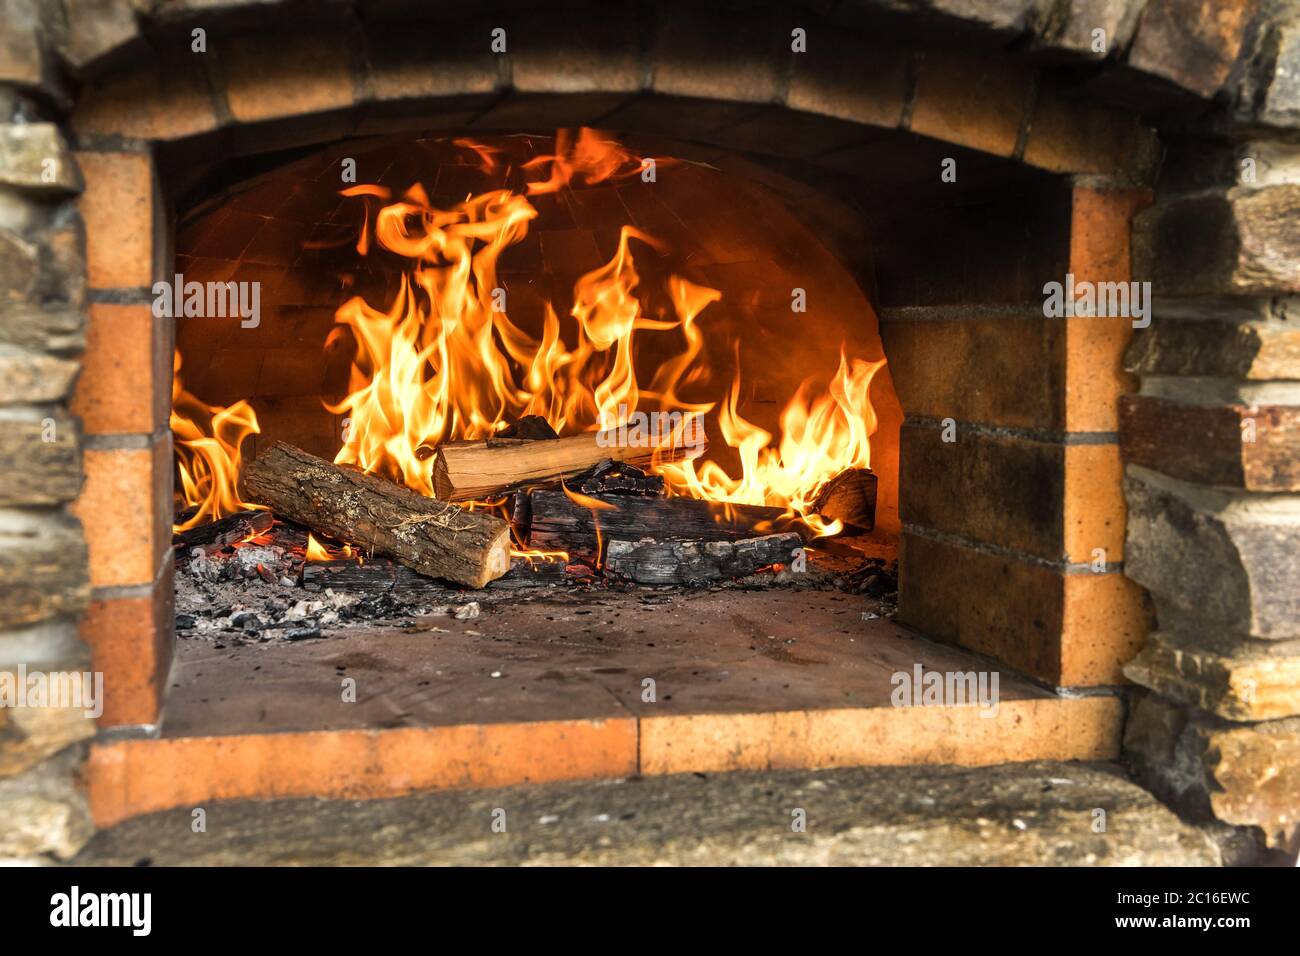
xmin=1121 ymin=395 xmax=1300 ymax=492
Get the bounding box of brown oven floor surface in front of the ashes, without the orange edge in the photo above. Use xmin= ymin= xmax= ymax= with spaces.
xmin=163 ymin=591 xmax=1052 ymax=737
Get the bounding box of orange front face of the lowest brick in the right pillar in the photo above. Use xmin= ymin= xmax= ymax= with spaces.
xmin=1057 ymin=574 xmax=1152 ymax=687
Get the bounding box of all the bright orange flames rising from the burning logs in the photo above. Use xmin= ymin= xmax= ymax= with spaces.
xmin=173 ymin=129 xmax=884 ymax=546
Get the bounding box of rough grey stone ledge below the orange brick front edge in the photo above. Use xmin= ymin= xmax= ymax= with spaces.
xmin=77 ymin=762 xmax=1219 ymax=866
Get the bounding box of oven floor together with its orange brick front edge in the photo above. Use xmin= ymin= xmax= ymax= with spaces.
xmin=90 ymin=589 xmax=1122 ymax=826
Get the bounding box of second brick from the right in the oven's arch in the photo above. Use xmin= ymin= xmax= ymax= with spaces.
xmin=911 ymin=53 xmax=1031 ymax=156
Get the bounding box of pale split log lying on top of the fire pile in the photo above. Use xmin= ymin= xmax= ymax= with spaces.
xmin=433 ymin=429 xmax=707 ymax=501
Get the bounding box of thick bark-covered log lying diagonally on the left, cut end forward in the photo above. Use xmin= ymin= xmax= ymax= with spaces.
xmin=244 ymin=442 xmax=510 ymax=588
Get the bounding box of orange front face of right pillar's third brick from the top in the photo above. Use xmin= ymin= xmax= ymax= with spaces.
xmin=1065 ymin=445 xmax=1125 ymax=563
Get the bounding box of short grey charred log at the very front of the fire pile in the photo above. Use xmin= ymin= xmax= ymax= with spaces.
xmin=605 ymin=532 xmax=803 ymax=585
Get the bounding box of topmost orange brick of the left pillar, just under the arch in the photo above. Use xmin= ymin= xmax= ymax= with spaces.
xmin=77 ymin=152 xmax=155 ymax=289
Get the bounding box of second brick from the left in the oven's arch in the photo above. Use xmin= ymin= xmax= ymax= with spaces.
xmin=221 ymin=34 xmax=352 ymax=122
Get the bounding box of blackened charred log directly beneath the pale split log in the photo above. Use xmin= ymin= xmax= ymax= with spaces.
xmin=528 ymin=489 xmax=785 ymax=551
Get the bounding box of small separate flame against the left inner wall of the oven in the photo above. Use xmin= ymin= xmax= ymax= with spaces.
xmin=172 ymin=352 xmax=265 ymax=532
